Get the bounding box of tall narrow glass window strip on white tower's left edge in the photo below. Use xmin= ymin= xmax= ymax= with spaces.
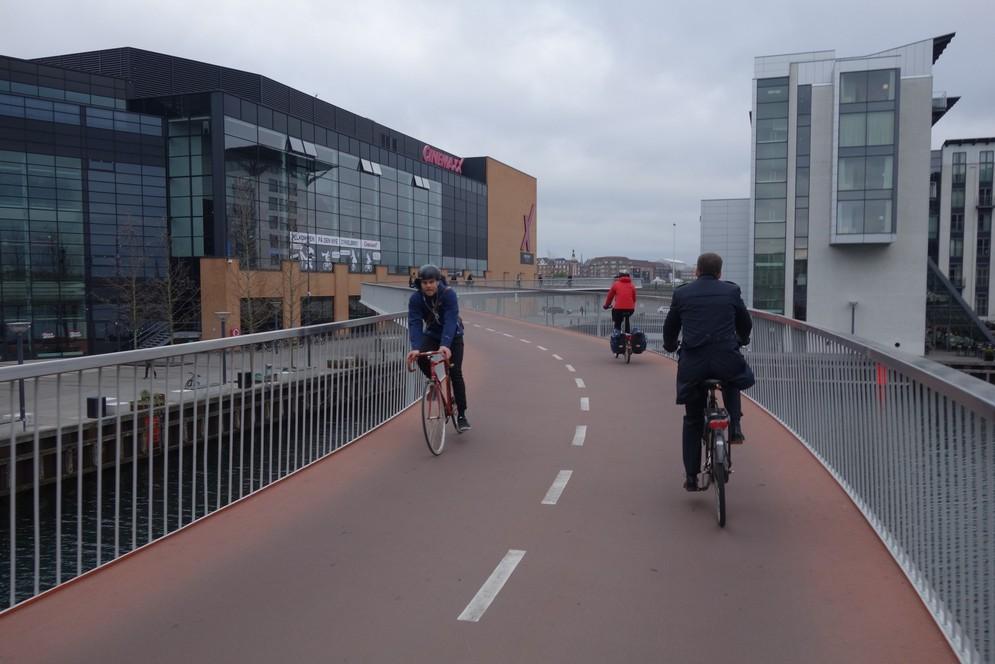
xmin=753 ymin=77 xmax=789 ymax=313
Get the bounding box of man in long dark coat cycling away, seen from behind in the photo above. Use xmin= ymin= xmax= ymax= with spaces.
xmin=663 ymin=253 xmax=755 ymax=491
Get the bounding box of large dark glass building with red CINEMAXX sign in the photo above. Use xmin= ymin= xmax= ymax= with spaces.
xmin=0 ymin=48 xmax=535 ymax=357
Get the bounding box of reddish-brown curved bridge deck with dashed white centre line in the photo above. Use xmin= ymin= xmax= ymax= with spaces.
xmin=0 ymin=314 xmax=954 ymax=663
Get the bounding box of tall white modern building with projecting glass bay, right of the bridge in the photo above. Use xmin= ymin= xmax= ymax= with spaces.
xmin=702 ymin=33 xmax=956 ymax=355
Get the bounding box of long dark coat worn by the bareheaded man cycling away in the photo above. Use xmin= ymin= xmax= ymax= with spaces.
xmin=663 ymin=276 xmax=755 ymax=403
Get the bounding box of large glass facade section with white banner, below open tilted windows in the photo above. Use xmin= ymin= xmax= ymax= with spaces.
xmin=225 ymin=117 xmax=442 ymax=273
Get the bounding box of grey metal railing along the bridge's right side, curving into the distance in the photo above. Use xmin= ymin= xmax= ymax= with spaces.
xmin=364 ymin=287 xmax=995 ymax=664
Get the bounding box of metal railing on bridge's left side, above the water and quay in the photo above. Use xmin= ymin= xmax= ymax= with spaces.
xmin=0 ymin=315 xmax=421 ymax=609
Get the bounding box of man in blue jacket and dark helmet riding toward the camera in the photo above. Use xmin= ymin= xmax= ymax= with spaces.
xmin=408 ymin=264 xmax=470 ymax=431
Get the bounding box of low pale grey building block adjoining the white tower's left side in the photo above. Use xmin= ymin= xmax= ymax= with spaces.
xmin=701 ymin=198 xmax=750 ymax=290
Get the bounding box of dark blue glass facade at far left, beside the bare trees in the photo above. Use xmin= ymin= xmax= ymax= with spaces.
xmin=0 ymin=85 xmax=166 ymax=359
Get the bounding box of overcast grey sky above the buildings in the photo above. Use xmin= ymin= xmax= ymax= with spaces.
xmin=0 ymin=0 xmax=995 ymax=260
